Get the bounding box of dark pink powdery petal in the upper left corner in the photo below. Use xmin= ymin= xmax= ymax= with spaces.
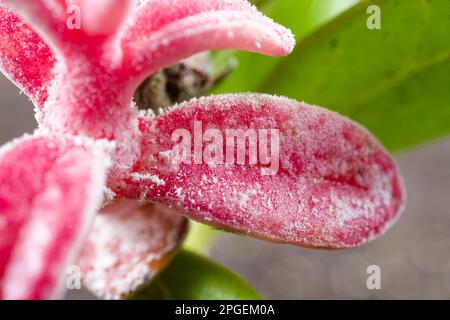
xmin=0 ymin=4 xmax=55 ymax=107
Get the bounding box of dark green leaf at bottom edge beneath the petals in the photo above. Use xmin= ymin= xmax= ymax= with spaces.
xmin=131 ymin=250 xmax=261 ymax=300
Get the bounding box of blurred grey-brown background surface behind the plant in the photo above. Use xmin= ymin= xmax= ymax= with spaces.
xmin=0 ymin=76 xmax=450 ymax=299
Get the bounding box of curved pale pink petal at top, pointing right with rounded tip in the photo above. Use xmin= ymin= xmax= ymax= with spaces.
xmin=123 ymin=0 xmax=295 ymax=79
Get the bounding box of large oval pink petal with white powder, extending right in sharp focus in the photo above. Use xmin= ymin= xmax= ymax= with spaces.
xmin=112 ymin=95 xmax=405 ymax=248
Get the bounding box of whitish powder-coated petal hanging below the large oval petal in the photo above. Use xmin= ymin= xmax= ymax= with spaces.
xmin=78 ymin=200 xmax=186 ymax=299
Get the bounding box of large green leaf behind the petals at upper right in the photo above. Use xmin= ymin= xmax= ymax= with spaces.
xmin=214 ymin=0 xmax=450 ymax=150
